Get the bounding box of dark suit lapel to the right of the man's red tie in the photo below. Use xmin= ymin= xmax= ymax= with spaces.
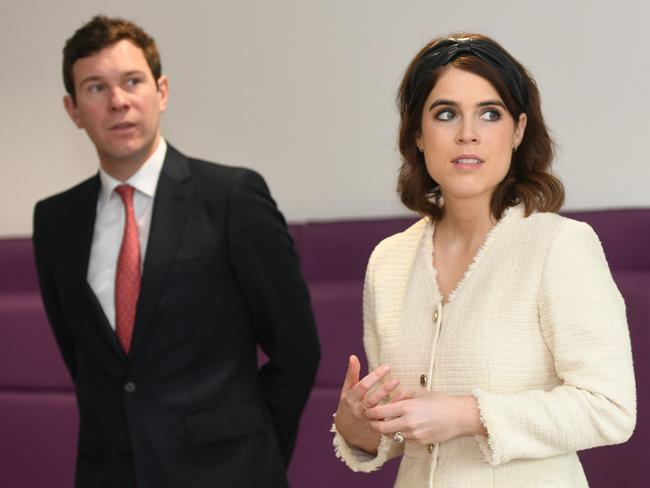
xmin=129 ymin=145 xmax=194 ymax=357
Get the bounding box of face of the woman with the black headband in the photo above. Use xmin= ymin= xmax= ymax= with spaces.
xmin=416 ymin=66 xmax=526 ymax=207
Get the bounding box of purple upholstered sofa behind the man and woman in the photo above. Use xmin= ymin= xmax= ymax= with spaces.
xmin=0 ymin=209 xmax=650 ymax=488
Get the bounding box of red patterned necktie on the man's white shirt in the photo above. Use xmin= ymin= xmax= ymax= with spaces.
xmin=115 ymin=185 xmax=140 ymax=354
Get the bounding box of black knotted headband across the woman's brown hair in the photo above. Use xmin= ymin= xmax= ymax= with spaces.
xmin=406 ymin=37 xmax=528 ymax=111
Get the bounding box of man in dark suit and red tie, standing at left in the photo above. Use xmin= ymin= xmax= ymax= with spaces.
xmin=34 ymin=16 xmax=319 ymax=488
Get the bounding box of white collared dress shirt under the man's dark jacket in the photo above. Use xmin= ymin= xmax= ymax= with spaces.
xmin=86 ymin=137 xmax=167 ymax=329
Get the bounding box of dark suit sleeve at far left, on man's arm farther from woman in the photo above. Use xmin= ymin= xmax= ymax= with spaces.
xmin=32 ymin=202 xmax=77 ymax=383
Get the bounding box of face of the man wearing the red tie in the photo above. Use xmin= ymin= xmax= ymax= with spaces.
xmin=64 ymin=40 xmax=168 ymax=176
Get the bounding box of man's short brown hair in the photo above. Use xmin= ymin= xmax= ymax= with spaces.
xmin=63 ymin=15 xmax=162 ymax=100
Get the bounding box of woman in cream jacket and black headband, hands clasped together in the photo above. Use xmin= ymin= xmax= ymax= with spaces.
xmin=333 ymin=34 xmax=636 ymax=488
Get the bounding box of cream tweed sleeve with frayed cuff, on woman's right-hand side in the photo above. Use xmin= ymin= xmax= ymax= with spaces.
xmin=474 ymin=221 xmax=636 ymax=465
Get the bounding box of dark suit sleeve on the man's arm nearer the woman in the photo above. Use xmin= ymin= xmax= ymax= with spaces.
xmin=228 ymin=170 xmax=320 ymax=464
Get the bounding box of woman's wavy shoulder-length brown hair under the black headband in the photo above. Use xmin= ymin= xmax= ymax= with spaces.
xmin=397 ymin=33 xmax=564 ymax=221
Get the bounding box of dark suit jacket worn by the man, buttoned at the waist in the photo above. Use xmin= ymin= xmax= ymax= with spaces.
xmin=34 ymin=146 xmax=319 ymax=488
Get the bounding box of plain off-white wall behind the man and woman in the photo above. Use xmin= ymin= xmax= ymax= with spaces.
xmin=0 ymin=0 xmax=650 ymax=236
